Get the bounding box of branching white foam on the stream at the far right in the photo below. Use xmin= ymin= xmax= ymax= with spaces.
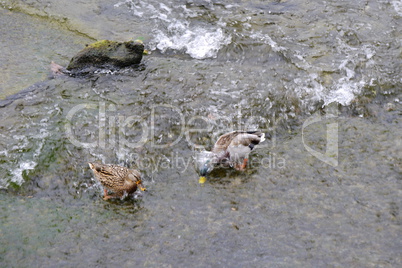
xmin=250 ymin=29 xmax=376 ymax=106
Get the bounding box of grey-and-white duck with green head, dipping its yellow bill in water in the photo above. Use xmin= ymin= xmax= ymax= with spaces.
xmin=199 ymin=131 xmax=265 ymax=183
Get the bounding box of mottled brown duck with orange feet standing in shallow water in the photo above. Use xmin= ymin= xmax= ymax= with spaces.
xmin=88 ymin=163 xmax=146 ymax=200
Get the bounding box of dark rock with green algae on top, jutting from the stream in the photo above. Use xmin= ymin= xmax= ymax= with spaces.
xmin=67 ymin=40 xmax=144 ymax=71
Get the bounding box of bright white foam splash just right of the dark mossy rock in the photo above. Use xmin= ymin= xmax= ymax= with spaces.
xmin=114 ymin=0 xmax=231 ymax=59
